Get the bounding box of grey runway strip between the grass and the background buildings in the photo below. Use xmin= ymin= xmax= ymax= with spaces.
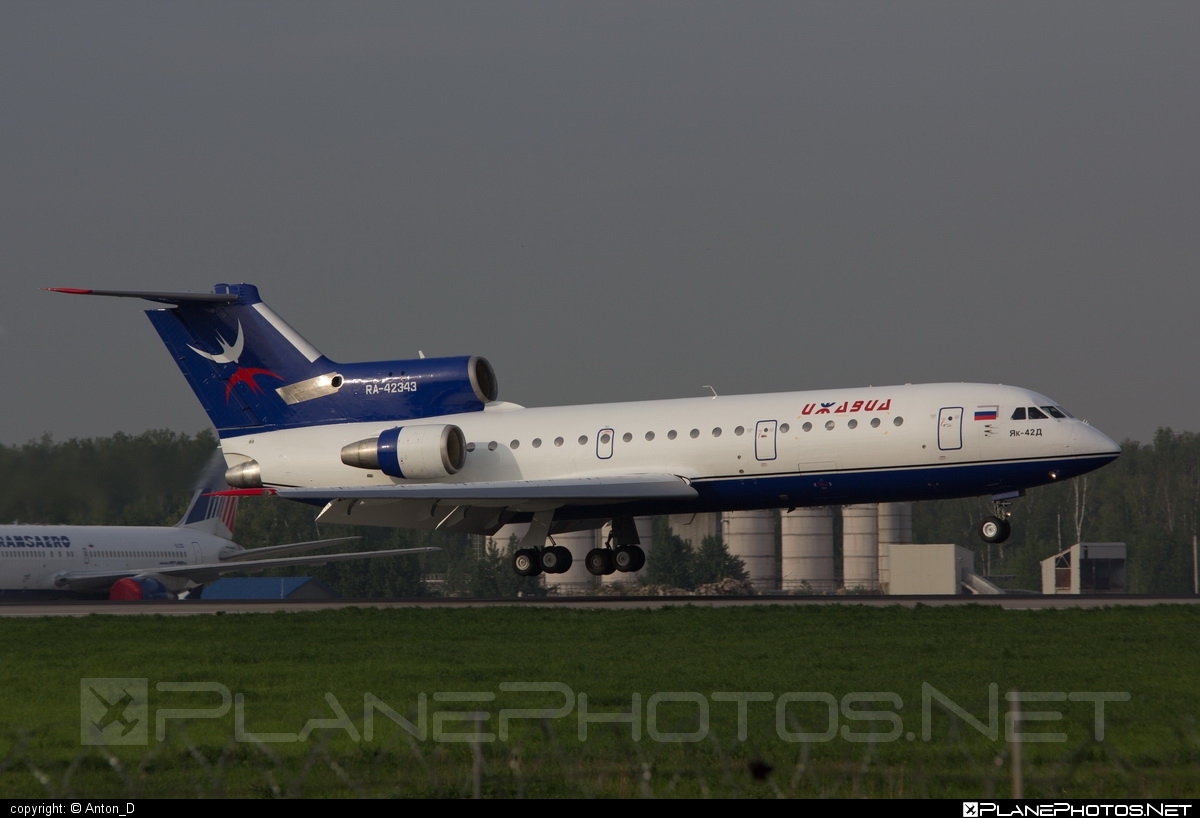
xmin=0 ymin=594 xmax=1200 ymax=618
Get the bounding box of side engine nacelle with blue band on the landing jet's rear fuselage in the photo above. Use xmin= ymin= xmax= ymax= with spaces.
xmin=342 ymin=425 xmax=467 ymax=480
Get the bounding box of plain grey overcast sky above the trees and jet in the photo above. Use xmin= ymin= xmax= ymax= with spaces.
xmin=0 ymin=0 xmax=1200 ymax=444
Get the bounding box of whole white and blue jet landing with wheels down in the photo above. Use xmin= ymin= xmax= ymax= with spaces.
xmin=48 ymin=284 xmax=1121 ymax=576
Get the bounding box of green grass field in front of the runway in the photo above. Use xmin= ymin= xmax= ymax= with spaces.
xmin=0 ymin=606 xmax=1200 ymax=798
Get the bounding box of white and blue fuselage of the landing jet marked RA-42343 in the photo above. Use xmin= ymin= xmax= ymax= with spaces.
xmin=222 ymin=384 xmax=1120 ymax=525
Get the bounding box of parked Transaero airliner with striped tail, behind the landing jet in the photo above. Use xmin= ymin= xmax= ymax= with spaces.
xmin=0 ymin=448 xmax=438 ymax=601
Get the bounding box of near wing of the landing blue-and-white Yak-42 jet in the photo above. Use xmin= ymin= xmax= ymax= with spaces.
xmin=271 ymin=474 xmax=696 ymax=506
